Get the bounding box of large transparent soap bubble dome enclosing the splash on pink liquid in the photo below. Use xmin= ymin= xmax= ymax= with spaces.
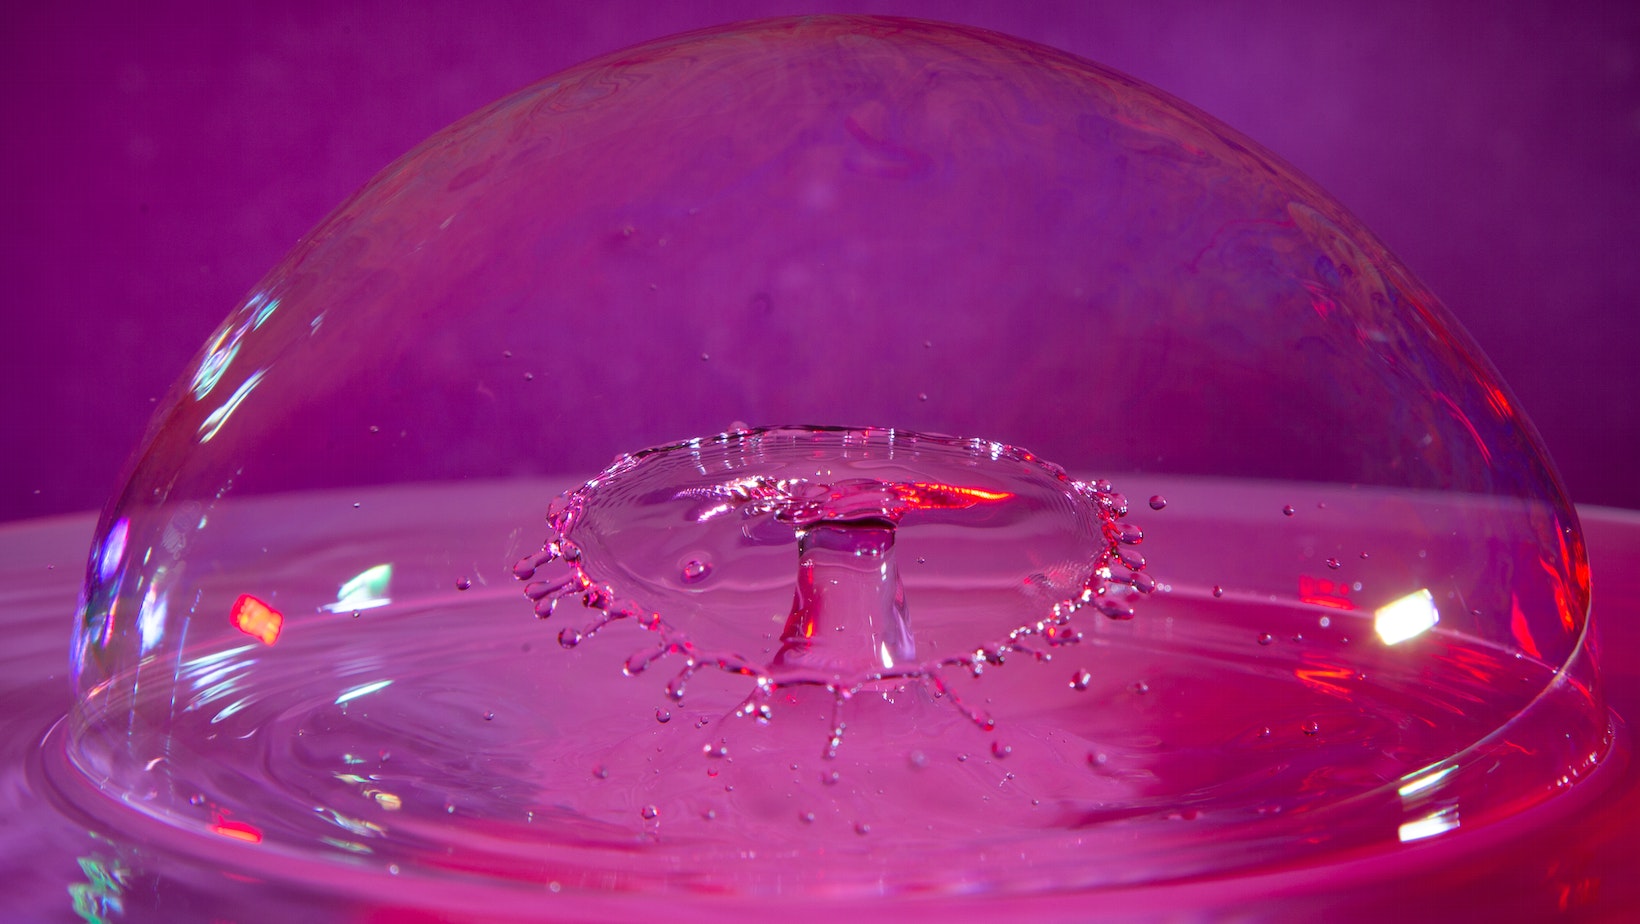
xmin=57 ymin=18 xmax=1612 ymax=914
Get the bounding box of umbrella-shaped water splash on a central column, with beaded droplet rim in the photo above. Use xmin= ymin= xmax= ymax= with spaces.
xmin=513 ymin=427 xmax=1155 ymax=757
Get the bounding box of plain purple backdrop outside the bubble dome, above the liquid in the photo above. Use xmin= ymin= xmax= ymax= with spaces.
xmin=9 ymin=0 xmax=1640 ymax=520
